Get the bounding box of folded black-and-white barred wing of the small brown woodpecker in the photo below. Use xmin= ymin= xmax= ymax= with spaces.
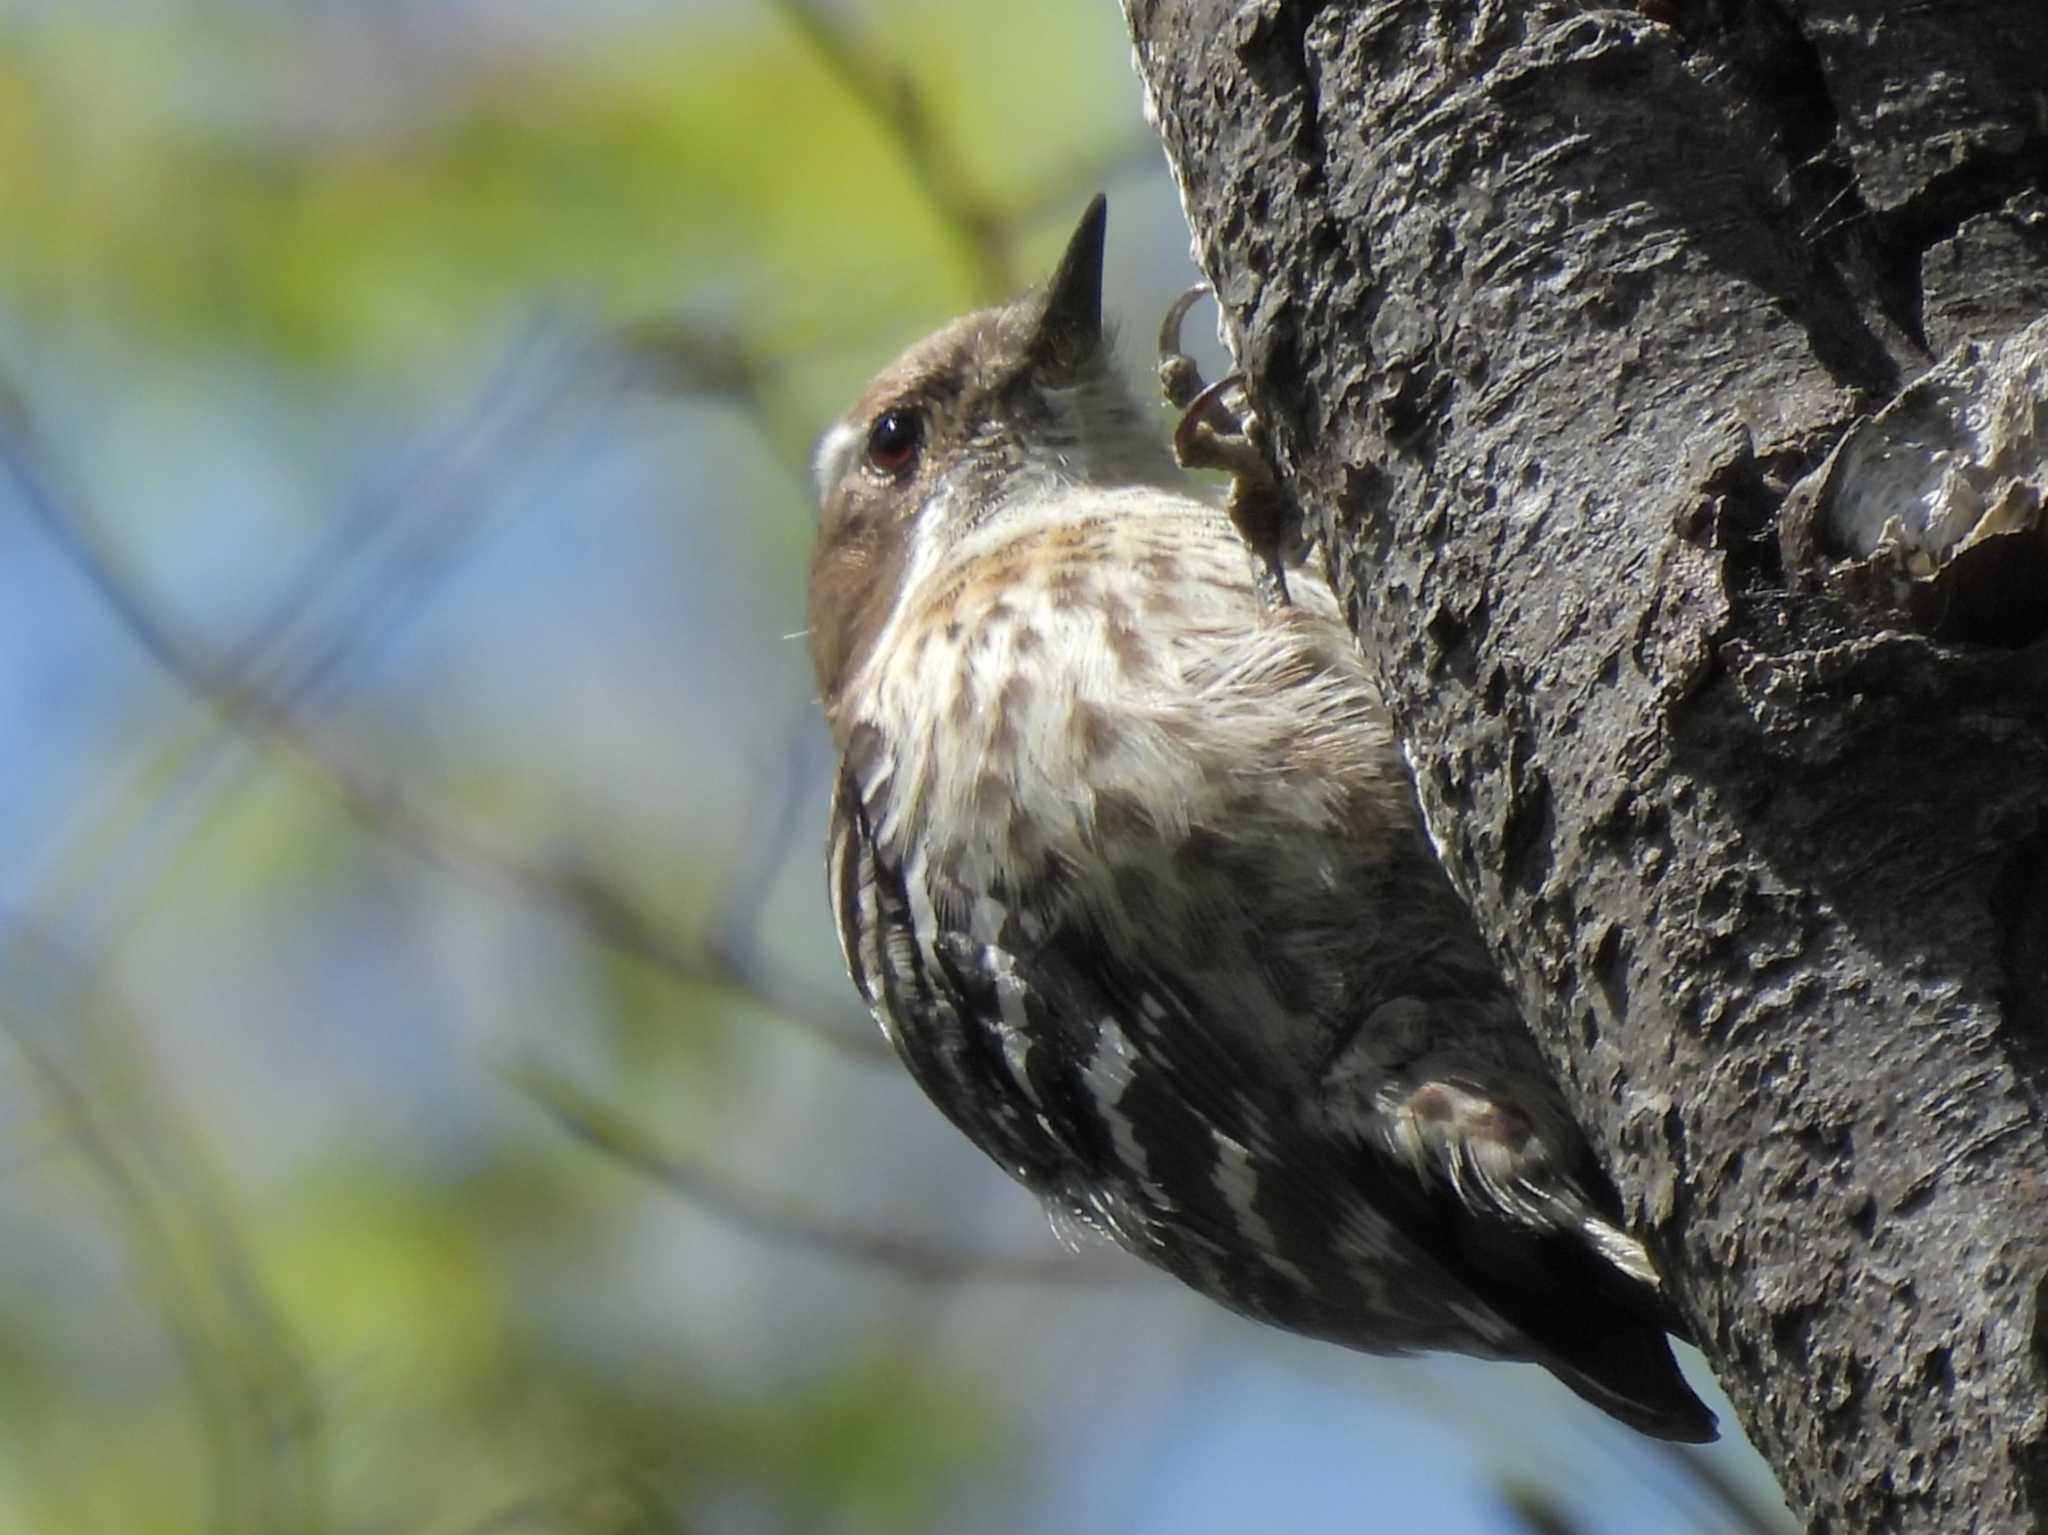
xmin=829 ymin=731 xmax=1530 ymax=1359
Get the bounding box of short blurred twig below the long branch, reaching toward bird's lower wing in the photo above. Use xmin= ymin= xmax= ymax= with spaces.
xmin=504 ymin=1062 xmax=1137 ymax=1285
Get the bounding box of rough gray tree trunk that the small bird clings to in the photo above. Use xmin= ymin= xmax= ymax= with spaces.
xmin=1126 ymin=0 xmax=2048 ymax=1533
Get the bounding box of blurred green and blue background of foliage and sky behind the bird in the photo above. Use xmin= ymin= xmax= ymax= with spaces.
xmin=0 ymin=0 xmax=1776 ymax=1535
